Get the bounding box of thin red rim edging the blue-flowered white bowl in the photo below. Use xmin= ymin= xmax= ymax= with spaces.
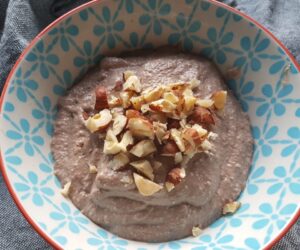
xmin=0 ymin=0 xmax=300 ymax=249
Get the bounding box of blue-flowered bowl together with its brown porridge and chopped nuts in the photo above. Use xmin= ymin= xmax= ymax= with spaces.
xmin=0 ymin=0 xmax=300 ymax=249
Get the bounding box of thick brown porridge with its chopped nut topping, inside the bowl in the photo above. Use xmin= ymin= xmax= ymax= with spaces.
xmin=51 ymin=50 xmax=253 ymax=242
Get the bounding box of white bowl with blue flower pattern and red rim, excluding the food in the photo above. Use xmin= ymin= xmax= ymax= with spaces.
xmin=0 ymin=0 xmax=300 ymax=250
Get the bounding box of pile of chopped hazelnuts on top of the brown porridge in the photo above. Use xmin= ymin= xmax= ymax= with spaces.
xmin=83 ymin=71 xmax=227 ymax=196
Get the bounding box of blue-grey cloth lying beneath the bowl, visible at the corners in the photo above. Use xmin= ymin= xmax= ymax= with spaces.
xmin=0 ymin=0 xmax=300 ymax=250
